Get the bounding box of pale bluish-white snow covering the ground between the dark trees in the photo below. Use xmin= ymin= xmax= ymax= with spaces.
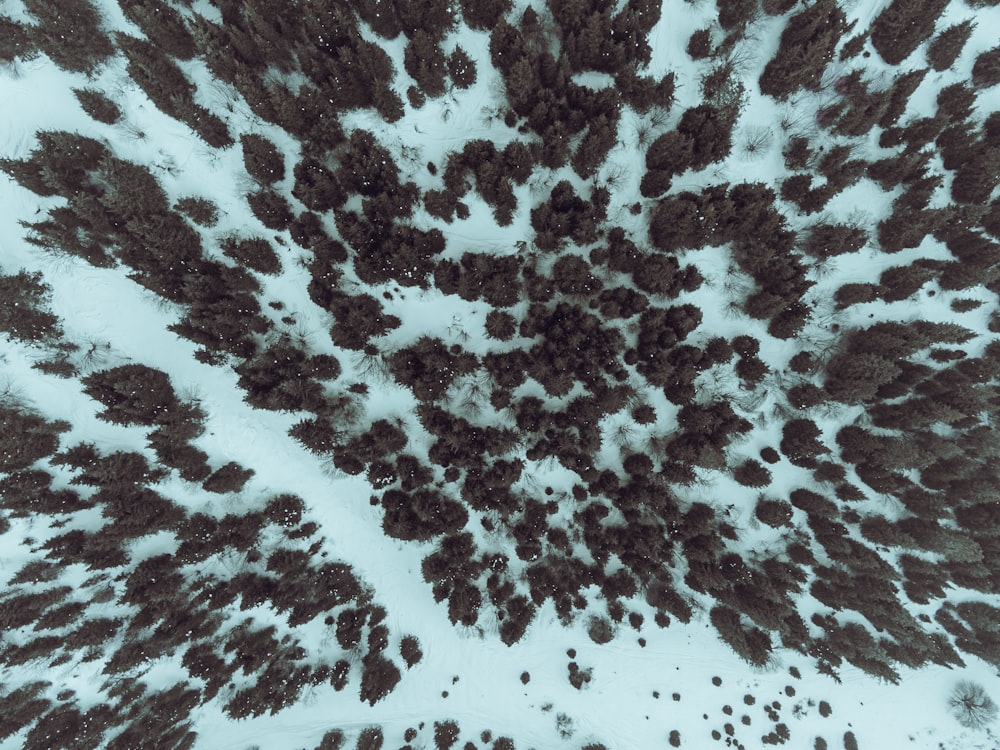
xmin=0 ymin=0 xmax=1000 ymax=750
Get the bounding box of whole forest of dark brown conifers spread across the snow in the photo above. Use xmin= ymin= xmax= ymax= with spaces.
xmin=0 ymin=0 xmax=1000 ymax=708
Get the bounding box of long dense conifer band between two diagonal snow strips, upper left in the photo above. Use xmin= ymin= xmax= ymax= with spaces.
xmin=0 ymin=137 xmax=271 ymax=357
